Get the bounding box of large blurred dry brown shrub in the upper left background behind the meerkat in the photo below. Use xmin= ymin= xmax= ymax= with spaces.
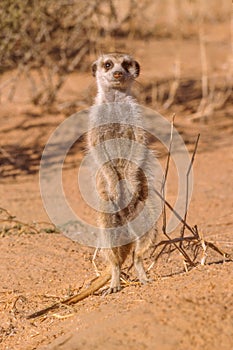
xmin=0 ymin=0 xmax=120 ymax=104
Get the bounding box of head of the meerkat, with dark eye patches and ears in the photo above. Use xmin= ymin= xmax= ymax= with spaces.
xmin=92 ymin=53 xmax=140 ymax=90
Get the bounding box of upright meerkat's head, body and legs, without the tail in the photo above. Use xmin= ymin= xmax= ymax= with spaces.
xmin=88 ymin=53 xmax=158 ymax=293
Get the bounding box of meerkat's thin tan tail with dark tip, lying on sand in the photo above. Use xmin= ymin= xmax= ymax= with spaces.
xmin=26 ymin=267 xmax=112 ymax=319
